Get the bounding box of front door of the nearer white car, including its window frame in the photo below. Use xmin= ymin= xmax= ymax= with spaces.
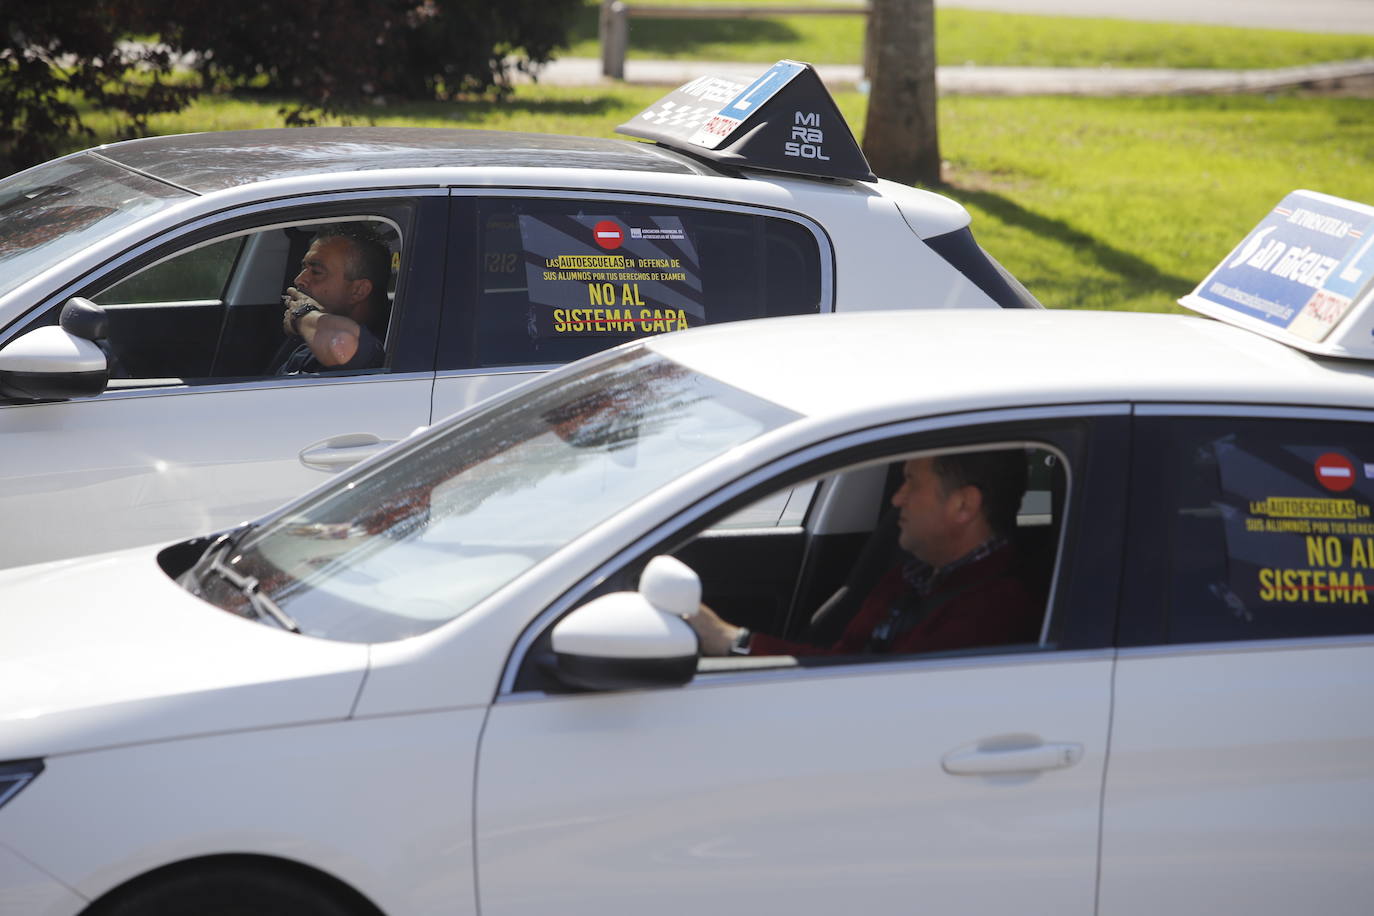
xmin=475 ymin=407 xmax=1125 ymax=916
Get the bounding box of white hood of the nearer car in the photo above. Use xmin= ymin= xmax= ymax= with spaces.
xmin=0 ymin=548 xmax=368 ymax=759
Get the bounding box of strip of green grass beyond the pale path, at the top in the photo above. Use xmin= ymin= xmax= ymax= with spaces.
xmin=566 ymin=0 xmax=1374 ymax=70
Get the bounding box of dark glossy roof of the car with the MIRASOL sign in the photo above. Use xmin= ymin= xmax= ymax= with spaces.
xmin=93 ymin=128 xmax=720 ymax=194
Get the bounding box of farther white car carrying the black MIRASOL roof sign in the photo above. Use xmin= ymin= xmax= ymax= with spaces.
xmin=0 ymin=62 xmax=1037 ymax=567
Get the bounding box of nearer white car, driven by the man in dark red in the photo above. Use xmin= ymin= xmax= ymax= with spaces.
xmin=8 ymin=189 xmax=1374 ymax=916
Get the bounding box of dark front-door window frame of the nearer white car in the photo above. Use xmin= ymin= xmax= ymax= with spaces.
xmin=497 ymin=402 xmax=1131 ymax=699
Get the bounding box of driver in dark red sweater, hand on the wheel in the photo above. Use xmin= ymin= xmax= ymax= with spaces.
xmin=690 ymin=449 xmax=1041 ymax=655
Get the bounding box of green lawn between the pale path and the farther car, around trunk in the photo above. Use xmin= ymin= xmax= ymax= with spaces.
xmin=72 ymin=87 xmax=1374 ymax=310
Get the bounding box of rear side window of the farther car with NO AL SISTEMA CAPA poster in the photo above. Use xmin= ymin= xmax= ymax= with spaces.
xmin=474 ymin=199 xmax=822 ymax=367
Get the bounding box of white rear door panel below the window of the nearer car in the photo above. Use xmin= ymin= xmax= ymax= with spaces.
xmin=1102 ymin=637 xmax=1374 ymax=916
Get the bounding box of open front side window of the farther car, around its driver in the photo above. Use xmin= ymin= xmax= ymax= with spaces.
xmin=25 ymin=203 xmax=409 ymax=387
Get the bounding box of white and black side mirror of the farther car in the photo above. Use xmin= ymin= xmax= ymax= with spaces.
xmin=0 ymin=325 xmax=110 ymax=401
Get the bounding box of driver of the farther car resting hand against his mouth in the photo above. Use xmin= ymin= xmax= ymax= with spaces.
xmin=275 ymin=222 xmax=392 ymax=375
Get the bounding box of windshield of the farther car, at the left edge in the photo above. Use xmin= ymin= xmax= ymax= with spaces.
xmin=0 ymin=154 xmax=192 ymax=297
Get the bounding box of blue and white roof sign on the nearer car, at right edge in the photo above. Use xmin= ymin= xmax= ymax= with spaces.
xmin=1179 ymin=191 xmax=1374 ymax=360
